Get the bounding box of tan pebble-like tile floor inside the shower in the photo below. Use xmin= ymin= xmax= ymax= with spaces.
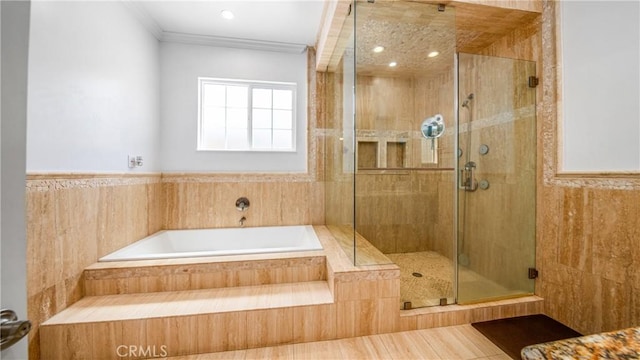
xmin=386 ymin=251 xmax=520 ymax=308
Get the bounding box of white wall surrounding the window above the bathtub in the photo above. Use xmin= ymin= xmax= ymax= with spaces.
xmin=160 ymin=42 xmax=307 ymax=172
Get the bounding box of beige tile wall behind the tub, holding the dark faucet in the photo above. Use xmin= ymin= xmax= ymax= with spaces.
xmin=163 ymin=174 xmax=324 ymax=229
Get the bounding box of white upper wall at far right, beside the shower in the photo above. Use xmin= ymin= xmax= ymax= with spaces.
xmin=561 ymin=1 xmax=640 ymax=172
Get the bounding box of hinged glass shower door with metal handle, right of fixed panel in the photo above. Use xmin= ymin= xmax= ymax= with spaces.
xmin=457 ymin=53 xmax=536 ymax=304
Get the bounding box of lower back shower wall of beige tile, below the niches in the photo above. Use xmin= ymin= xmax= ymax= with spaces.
xmin=356 ymin=170 xmax=453 ymax=258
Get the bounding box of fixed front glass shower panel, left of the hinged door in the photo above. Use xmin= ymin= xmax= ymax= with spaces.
xmin=354 ymin=1 xmax=456 ymax=309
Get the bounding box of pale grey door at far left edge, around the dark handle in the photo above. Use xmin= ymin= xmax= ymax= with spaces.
xmin=0 ymin=1 xmax=30 ymax=359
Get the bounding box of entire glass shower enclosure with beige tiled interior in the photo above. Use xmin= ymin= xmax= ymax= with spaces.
xmin=323 ymin=1 xmax=536 ymax=309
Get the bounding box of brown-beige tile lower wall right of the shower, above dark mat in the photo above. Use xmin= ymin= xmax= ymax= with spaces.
xmin=537 ymin=186 xmax=640 ymax=333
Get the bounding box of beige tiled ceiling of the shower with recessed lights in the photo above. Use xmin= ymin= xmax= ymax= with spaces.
xmin=316 ymin=0 xmax=540 ymax=76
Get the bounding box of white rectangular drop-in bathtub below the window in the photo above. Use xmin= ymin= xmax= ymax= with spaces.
xmin=98 ymin=225 xmax=322 ymax=261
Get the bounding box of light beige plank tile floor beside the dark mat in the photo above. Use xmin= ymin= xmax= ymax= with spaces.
xmin=170 ymin=325 xmax=510 ymax=360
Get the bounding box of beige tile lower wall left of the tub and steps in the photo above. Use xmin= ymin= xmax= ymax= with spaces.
xmin=26 ymin=174 xmax=164 ymax=359
